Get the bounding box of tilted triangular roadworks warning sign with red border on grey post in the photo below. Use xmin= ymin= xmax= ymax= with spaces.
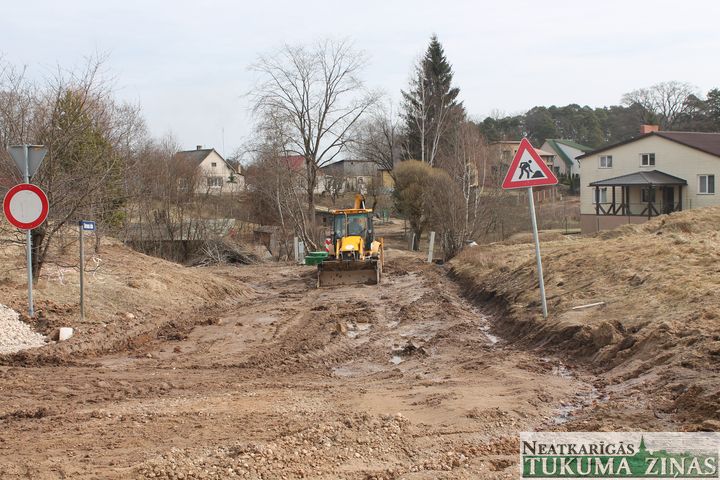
xmin=502 ymin=138 xmax=558 ymax=318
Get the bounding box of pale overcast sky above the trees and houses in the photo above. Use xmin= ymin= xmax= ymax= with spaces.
xmin=0 ymin=0 xmax=720 ymax=154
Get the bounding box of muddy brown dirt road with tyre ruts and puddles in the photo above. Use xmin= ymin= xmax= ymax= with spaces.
xmin=0 ymin=250 xmax=596 ymax=479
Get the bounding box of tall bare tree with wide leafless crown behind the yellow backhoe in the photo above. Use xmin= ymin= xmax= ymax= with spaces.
xmin=250 ymin=40 xmax=378 ymax=248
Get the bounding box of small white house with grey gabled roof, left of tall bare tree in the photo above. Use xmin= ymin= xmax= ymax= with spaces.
xmin=175 ymin=145 xmax=245 ymax=194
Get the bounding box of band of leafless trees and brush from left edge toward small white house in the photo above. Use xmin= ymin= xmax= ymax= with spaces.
xmin=0 ymin=58 xmax=245 ymax=280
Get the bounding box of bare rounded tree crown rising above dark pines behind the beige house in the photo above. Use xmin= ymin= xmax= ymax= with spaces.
xmin=622 ymin=80 xmax=698 ymax=130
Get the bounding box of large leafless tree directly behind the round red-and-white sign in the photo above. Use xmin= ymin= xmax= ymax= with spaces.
xmin=0 ymin=57 xmax=148 ymax=279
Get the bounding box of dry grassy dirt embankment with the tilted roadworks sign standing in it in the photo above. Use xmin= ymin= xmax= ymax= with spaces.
xmin=451 ymin=208 xmax=720 ymax=430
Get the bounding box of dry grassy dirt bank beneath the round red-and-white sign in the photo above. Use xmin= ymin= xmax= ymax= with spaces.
xmin=0 ymin=238 xmax=255 ymax=365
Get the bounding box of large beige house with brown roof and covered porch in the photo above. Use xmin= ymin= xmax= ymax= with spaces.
xmin=578 ymin=125 xmax=720 ymax=233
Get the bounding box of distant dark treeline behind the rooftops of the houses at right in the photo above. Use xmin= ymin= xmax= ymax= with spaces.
xmin=478 ymin=81 xmax=720 ymax=148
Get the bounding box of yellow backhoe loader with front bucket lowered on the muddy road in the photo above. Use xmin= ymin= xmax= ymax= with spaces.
xmin=306 ymin=194 xmax=383 ymax=287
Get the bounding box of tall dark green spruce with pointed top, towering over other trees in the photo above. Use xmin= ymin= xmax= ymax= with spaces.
xmin=402 ymin=35 xmax=465 ymax=165
